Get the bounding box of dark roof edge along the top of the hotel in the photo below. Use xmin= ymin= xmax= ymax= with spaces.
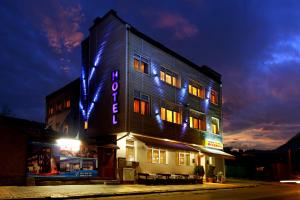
xmin=89 ymin=10 xmax=222 ymax=84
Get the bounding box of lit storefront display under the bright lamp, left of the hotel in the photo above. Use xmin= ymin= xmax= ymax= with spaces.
xmin=27 ymin=143 xmax=98 ymax=177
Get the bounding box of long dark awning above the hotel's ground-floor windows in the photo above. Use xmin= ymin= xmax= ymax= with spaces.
xmin=134 ymin=135 xmax=198 ymax=152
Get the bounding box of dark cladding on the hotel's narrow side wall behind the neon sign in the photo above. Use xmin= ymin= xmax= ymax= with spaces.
xmin=88 ymin=16 xmax=126 ymax=136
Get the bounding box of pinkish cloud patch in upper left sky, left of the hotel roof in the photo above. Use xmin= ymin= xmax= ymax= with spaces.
xmin=42 ymin=4 xmax=84 ymax=53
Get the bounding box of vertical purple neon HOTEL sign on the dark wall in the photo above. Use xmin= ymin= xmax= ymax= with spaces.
xmin=111 ymin=70 xmax=119 ymax=125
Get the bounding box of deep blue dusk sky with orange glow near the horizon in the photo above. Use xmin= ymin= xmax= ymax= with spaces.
xmin=0 ymin=0 xmax=300 ymax=149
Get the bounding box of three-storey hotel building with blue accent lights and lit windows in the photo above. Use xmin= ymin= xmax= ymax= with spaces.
xmin=80 ymin=11 xmax=230 ymax=179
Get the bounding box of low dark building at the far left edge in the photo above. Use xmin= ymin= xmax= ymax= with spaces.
xmin=0 ymin=116 xmax=57 ymax=185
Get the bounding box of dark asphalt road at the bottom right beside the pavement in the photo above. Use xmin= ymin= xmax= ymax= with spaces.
xmin=83 ymin=184 xmax=300 ymax=200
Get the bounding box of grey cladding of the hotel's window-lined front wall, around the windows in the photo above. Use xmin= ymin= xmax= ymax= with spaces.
xmin=128 ymin=31 xmax=222 ymax=144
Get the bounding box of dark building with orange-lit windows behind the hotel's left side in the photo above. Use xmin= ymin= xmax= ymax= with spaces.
xmin=45 ymin=78 xmax=80 ymax=137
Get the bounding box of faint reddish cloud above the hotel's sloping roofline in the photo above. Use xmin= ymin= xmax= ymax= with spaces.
xmin=145 ymin=11 xmax=199 ymax=40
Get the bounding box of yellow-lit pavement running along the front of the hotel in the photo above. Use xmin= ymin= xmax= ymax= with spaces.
xmin=0 ymin=181 xmax=260 ymax=199
